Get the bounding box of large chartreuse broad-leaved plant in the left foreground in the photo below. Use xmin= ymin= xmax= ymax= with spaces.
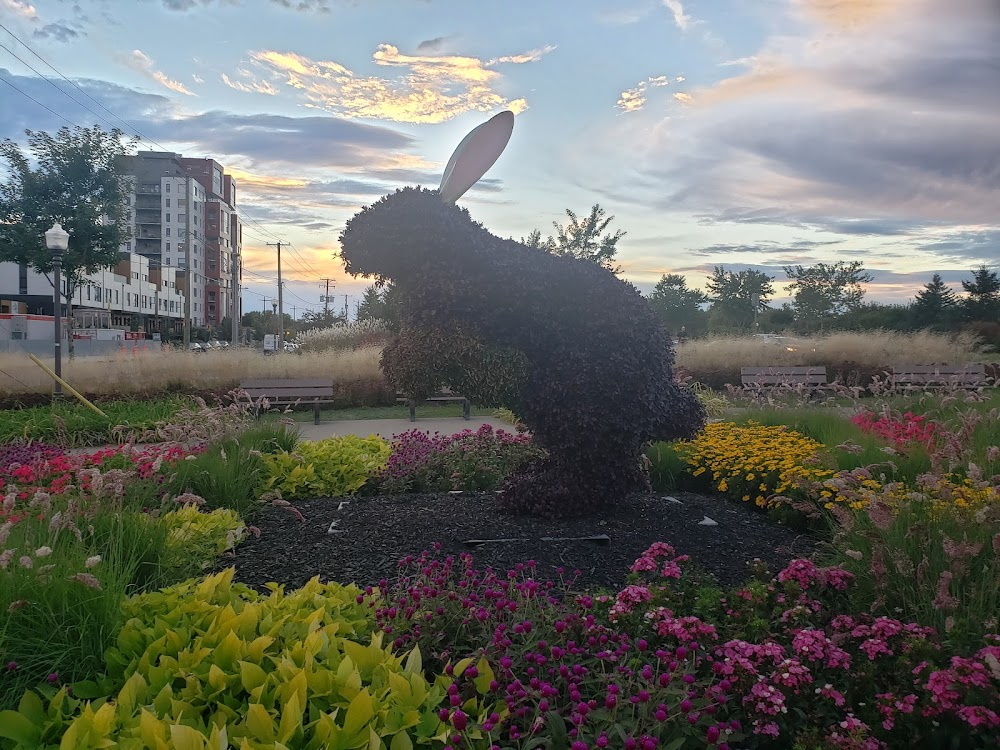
xmin=0 ymin=569 xmax=488 ymax=750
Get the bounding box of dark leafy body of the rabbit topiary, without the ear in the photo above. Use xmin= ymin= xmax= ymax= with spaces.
xmin=341 ymin=188 xmax=705 ymax=517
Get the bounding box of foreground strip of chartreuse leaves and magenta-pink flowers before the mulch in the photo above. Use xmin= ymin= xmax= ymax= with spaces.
xmin=9 ymin=543 xmax=1000 ymax=750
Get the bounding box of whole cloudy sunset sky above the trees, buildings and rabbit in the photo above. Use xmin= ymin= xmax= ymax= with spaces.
xmin=0 ymin=0 xmax=1000 ymax=315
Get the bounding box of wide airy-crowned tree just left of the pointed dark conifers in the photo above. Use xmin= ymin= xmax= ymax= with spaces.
xmin=784 ymin=260 xmax=873 ymax=324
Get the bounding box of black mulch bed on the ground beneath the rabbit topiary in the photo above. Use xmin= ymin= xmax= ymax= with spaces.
xmin=220 ymin=493 xmax=818 ymax=590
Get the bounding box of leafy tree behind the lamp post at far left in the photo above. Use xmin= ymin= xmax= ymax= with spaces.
xmin=0 ymin=126 xmax=135 ymax=356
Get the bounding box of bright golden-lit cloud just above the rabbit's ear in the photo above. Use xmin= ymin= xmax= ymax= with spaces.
xmin=251 ymin=44 xmax=555 ymax=123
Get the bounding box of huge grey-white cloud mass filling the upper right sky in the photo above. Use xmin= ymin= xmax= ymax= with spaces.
xmin=576 ymin=0 xmax=1000 ymax=248
